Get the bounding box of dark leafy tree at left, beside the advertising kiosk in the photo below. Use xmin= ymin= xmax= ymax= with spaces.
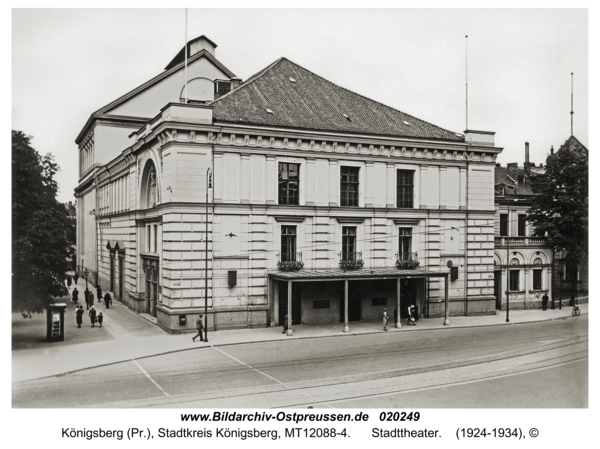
xmin=12 ymin=130 xmax=74 ymax=316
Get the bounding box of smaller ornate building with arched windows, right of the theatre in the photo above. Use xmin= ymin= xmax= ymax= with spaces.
xmin=494 ymin=143 xmax=553 ymax=310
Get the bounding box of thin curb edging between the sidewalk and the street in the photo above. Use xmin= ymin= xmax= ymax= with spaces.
xmin=18 ymin=313 xmax=589 ymax=383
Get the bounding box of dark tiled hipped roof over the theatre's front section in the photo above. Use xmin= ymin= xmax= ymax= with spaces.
xmin=212 ymin=58 xmax=464 ymax=142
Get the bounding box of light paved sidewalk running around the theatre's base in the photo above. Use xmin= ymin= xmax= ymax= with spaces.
xmin=12 ymin=286 xmax=588 ymax=383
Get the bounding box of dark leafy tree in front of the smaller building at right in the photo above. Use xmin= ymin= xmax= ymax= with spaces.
xmin=527 ymin=136 xmax=588 ymax=304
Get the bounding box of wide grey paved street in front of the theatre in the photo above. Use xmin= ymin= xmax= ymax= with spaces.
xmin=13 ymin=312 xmax=588 ymax=408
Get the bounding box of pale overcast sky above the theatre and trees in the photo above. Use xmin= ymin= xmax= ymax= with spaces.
xmin=11 ymin=8 xmax=589 ymax=202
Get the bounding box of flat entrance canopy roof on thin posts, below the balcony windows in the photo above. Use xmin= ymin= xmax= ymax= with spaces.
xmin=269 ymin=268 xmax=450 ymax=282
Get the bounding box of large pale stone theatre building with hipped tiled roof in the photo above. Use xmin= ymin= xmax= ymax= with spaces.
xmin=76 ymin=36 xmax=501 ymax=331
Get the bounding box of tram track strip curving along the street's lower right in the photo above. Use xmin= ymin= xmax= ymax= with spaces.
xmin=94 ymin=337 xmax=588 ymax=408
